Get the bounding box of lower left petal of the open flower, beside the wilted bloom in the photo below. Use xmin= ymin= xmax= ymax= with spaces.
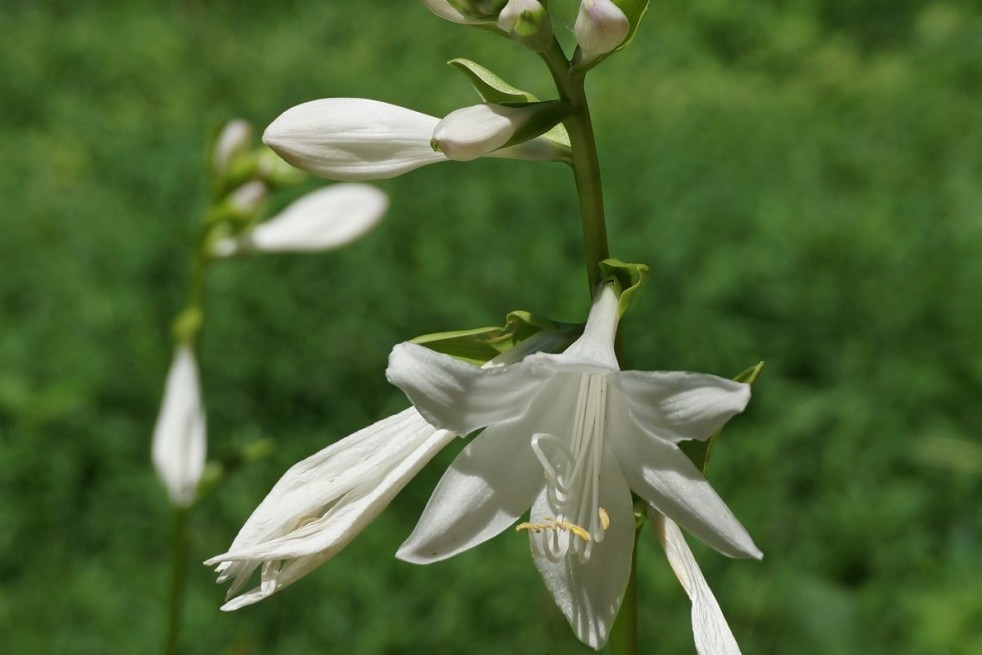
xmin=396 ymin=417 xmax=543 ymax=564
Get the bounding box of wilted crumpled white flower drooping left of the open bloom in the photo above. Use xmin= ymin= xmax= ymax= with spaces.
xmin=205 ymin=408 xmax=455 ymax=611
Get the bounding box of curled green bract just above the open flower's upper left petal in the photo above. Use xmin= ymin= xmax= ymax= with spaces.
xmin=411 ymin=311 xmax=583 ymax=366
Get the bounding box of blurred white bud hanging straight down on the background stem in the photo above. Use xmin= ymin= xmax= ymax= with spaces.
xmin=151 ymin=345 xmax=206 ymax=507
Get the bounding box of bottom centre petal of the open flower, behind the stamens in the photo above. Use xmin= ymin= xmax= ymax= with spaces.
xmin=529 ymin=452 xmax=635 ymax=650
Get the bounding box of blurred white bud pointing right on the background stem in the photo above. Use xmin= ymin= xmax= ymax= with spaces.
xmin=212 ymin=183 xmax=389 ymax=257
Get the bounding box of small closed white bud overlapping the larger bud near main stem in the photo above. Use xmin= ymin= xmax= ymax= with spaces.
xmin=433 ymin=103 xmax=538 ymax=161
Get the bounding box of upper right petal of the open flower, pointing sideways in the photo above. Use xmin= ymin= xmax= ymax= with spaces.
xmin=612 ymin=371 xmax=750 ymax=443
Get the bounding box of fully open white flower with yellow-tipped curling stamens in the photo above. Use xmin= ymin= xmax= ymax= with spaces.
xmin=387 ymin=285 xmax=761 ymax=649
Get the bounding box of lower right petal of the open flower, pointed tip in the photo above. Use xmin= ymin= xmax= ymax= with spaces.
xmin=607 ymin=388 xmax=763 ymax=559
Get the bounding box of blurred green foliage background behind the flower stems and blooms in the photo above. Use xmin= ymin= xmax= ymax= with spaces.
xmin=0 ymin=0 xmax=982 ymax=655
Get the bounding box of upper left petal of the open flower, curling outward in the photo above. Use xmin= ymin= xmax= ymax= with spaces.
xmin=385 ymin=343 xmax=553 ymax=436
